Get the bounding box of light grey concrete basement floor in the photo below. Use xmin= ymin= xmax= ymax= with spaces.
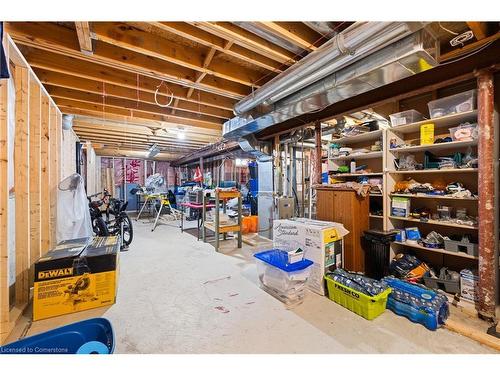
xmin=7 ymin=219 xmax=498 ymax=353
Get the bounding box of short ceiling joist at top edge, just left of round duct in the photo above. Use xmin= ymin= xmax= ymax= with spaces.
xmin=257 ymin=22 xmax=321 ymax=51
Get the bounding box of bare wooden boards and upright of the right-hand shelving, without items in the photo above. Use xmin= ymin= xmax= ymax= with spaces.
xmin=384 ymin=111 xmax=478 ymax=261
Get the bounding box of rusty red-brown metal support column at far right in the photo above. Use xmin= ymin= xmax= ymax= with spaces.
xmin=476 ymin=69 xmax=498 ymax=319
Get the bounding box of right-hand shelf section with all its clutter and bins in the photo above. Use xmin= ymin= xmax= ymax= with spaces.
xmin=384 ymin=86 xmax=479 ymax=280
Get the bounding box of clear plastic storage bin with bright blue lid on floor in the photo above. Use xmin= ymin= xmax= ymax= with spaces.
xmin=254 ymin=249 xmax=313 ymax=307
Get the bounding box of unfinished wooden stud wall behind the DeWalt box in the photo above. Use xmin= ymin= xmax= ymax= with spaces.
xmin=0 ymin=37 xmax=62 ymax=345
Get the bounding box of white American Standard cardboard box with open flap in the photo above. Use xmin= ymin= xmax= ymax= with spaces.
xmin=273 ymin=218 xmax=349 ymax=295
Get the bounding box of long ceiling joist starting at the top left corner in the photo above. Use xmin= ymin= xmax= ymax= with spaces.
xmin=7 ymin=22 xmax=250 ymax=99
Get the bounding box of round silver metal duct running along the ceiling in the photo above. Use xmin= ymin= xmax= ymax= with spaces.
xmin=234 ymin=22 xmax=425 ymax=115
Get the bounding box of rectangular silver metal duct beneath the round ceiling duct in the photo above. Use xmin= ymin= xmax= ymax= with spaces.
xmin=223 ymin=29 xmax=439 ymax=139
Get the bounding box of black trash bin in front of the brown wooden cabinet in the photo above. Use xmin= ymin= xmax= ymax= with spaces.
xmin=363 ymin=229 xmax=396 ymax=280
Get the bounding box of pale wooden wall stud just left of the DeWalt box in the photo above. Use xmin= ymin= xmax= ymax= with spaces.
xmin=14 ymin=66 xmax=30 ymax=306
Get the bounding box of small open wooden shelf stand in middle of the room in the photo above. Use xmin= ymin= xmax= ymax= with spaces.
xmin=203 ymin=190 xmax=242 ymax=251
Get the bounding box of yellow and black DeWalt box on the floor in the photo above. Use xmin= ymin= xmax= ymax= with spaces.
xmin=33 ymin=237 xmax=120 ymax=320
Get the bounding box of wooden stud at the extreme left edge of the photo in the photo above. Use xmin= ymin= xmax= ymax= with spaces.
xmin=0 ymin=47 xmax=9 ymax=344
